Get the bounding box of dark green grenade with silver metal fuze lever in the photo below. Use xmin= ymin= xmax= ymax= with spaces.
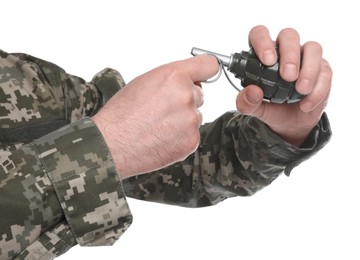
xmin=191 ymin=47 xmax=303 ymax=104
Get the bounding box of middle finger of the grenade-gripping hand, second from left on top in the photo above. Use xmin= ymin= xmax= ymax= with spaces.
xmin=277 ymin=28 xmax=301 ymax=81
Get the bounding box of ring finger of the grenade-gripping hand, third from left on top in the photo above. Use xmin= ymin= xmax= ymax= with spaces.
xmin=296 ymin=42 xmax=322 ymax=95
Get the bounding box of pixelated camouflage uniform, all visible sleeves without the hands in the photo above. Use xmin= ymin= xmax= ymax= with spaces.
xmin=0 ymin=50 xmax=331 ymax=260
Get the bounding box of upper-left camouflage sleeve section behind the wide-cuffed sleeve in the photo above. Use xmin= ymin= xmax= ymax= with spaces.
xmin=0 ymin=50 xmax=125 ymax=136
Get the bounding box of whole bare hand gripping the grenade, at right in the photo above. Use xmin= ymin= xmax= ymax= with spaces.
xmin=236 ymin=25 xmax=332 ymax=145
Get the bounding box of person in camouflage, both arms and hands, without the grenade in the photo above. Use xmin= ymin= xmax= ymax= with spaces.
xmin=0 ymin=26 xmax=332 ymax=259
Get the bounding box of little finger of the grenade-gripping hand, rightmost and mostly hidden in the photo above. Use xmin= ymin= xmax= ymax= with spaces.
xmin=300 ymin=59 xmax=332 ymax=112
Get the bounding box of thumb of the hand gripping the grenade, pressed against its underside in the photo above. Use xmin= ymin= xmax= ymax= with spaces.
xmin=236 ymin=85 xmax=265 ymax=119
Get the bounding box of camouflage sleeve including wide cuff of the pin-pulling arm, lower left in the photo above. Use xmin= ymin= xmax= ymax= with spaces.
xmin=0 ymin=118 xmax=132 ymax=259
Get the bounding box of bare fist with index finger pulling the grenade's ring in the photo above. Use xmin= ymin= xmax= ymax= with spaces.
xmin=93 ymin=55 xmax=219 ymax=179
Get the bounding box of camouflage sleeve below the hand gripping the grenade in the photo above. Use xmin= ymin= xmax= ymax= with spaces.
xmin=123 ymin=112 xmax=331 ymax=207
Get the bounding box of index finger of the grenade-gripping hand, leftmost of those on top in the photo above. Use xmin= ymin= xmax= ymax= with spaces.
xmin=249 ymin=25 xmax=277 ymax=66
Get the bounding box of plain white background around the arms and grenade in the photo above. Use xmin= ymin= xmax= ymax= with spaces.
xmin=0 ymin=0 xmax=360 ymax=260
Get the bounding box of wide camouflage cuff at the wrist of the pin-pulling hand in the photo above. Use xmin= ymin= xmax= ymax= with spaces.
xmin=33 ymin=118 xmax=132 ymax=246
